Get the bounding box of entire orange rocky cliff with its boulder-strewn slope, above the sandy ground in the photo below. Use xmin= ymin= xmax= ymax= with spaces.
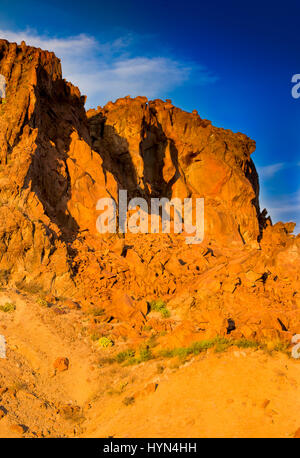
xmin=0 ymin=40 xmax=300 ymax=339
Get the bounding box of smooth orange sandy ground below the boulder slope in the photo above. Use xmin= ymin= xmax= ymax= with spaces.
xmin=0 ymin=291 xmax=300 ymax=438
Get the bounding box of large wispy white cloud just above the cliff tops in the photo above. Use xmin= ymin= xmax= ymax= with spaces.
xmin=0 ymin=29 xmax=217 ymax=106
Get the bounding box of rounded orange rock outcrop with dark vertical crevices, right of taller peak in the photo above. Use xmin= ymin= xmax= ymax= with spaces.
xmin=88 ymin=97 xmax=260 ymax=244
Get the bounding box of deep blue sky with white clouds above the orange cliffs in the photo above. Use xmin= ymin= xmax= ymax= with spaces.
xmin=0 ymin=0 xmax=300 ymax=229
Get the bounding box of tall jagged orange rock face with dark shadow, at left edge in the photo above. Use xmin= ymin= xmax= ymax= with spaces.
xmin=0 ymin=40 xmax=113 ymax=291
